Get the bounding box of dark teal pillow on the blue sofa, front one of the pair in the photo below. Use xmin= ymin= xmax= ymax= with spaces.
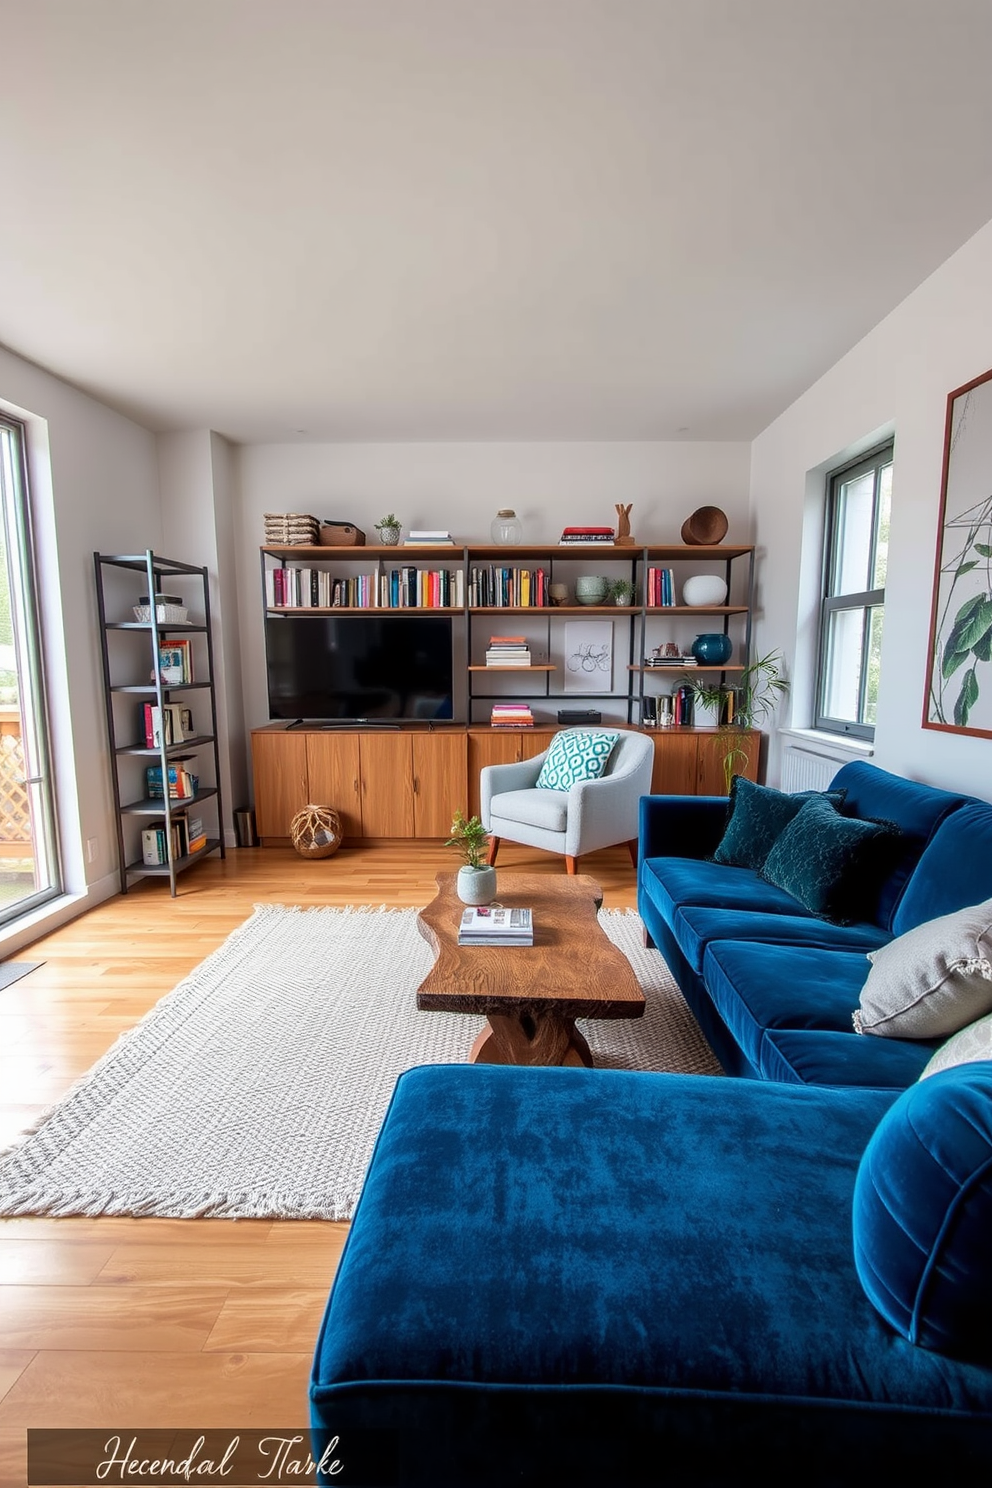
xmin=761 ymin=796 xmax=898 ymax=924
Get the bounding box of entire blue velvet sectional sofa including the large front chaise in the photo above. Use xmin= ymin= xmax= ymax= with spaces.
xmin=311 ymin=765 xmax=992 ymax=1488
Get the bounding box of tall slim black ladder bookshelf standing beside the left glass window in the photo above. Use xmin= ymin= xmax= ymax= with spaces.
xmin=94 ymin=549 xmax=225 ymax=896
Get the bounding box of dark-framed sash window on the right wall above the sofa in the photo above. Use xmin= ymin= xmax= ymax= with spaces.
xmin=817 ymin=445 xmax=892 ymax=740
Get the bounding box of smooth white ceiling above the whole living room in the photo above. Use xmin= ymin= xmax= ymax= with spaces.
xmin=0 ymin=0 xmax=992 ymax=442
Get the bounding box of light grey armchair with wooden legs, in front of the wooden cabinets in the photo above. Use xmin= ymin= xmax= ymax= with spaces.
xmin=480 ymin=731 xmax=654 ymax=873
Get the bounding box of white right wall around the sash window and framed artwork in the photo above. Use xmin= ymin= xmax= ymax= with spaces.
xmin=751 ymin=212 xmax=992 ymax=798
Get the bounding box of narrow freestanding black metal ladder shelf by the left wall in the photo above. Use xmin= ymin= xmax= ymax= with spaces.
xmin=94 ymin=549 xmax=226 ymax=896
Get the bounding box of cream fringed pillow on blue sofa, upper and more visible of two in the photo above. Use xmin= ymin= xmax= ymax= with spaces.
xmin=854 ymin=899 xmax=992 ymax=1039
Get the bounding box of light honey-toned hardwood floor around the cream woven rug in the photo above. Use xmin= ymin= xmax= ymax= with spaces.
xmin=0 ymin=842 xmax=635 ymax=1488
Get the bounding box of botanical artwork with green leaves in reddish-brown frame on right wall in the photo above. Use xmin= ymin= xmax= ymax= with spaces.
xmin=924 ymin=371 xmax=992 ymax=738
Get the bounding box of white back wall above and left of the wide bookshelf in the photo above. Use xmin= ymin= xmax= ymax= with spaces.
xmin=238 ymin=442 xmax=750 ymax=744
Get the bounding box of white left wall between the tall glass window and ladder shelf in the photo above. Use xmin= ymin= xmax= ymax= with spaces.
xmin=0 ymin=347 xmax=161 ymax=951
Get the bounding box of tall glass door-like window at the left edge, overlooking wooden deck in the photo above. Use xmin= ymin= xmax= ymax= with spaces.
xmin=0 ymin=412 xmax=61 ymax=924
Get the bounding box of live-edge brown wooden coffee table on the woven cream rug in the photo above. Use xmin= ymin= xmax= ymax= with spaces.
xmin=416 ymin=873 xmax=644 ymax=1067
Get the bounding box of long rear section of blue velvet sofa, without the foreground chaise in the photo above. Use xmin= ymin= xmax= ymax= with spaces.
xmin=638 ymin=762 xmax=992 ymax=1091
